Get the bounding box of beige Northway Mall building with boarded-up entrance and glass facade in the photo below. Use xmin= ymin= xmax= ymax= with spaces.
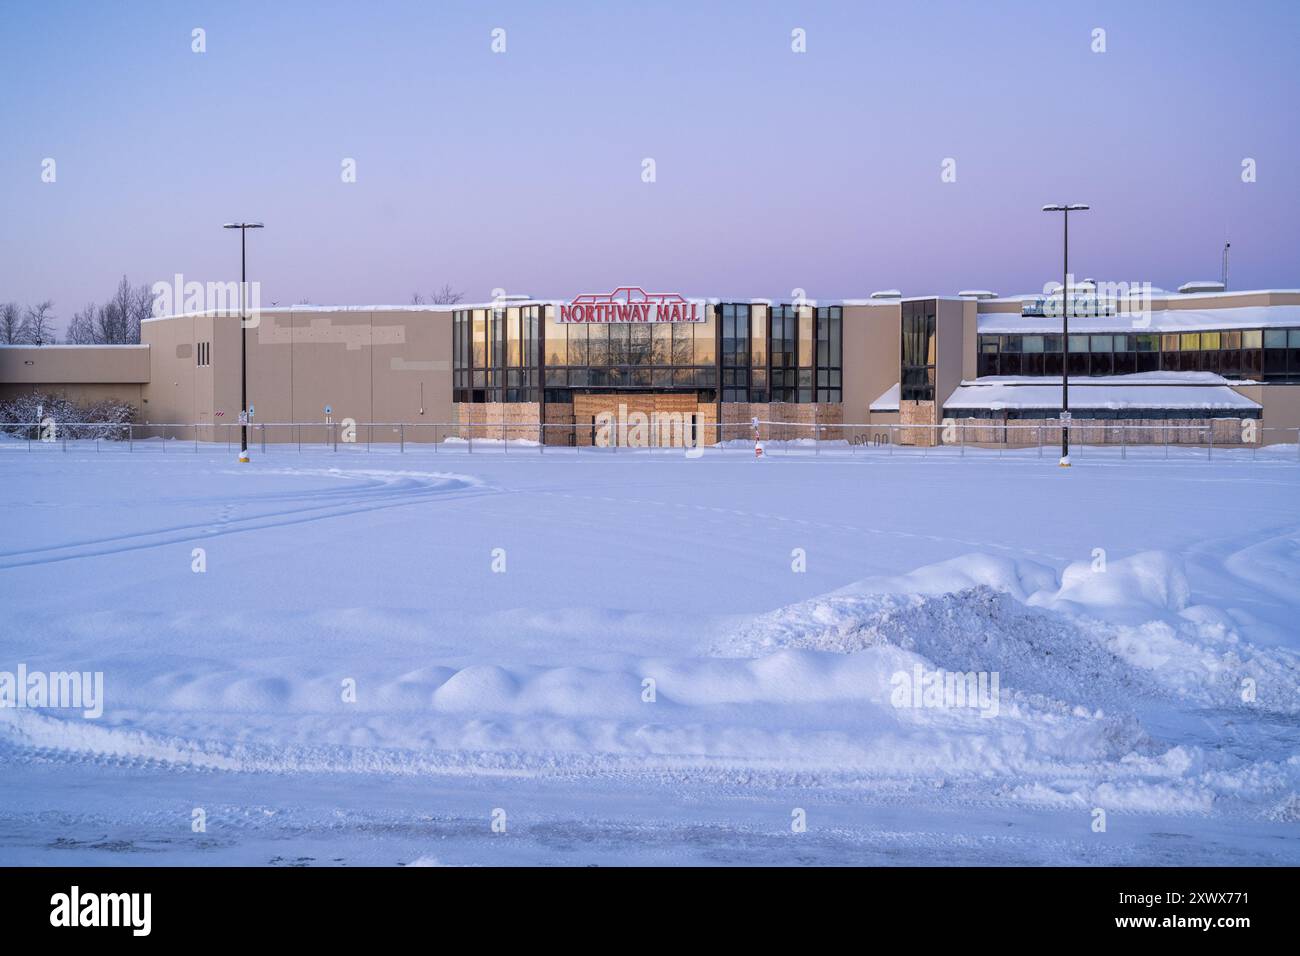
xmin=0 ymin=281 xmax=1300 ymax=445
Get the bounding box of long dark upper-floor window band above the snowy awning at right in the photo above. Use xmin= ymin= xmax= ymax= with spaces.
xmin=978 ymin=329 xmax=1300 ymax=382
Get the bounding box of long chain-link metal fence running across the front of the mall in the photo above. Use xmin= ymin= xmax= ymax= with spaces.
xmin=0 ymin=416 xmax=1300 ymax=460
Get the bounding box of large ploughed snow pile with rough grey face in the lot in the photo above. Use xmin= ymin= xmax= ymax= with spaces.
xmin=719 ymin=551 xmax=1300 ymax=714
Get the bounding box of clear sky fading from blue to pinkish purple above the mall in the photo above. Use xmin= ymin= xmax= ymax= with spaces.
xmin=0 ymin=0 xmax=1300 ymax=324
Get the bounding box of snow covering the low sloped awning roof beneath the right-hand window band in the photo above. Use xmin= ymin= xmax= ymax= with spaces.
xmin=944 ymin=372 xmax=1262 ymax=411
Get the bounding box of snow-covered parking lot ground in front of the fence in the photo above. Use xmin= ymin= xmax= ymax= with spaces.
xmin=0 ymin=445 xmax=1300 ymax=865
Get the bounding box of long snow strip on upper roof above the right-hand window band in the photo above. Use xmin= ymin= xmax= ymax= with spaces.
xmin=975 ymin=306 xmax=1300 ymax=334
